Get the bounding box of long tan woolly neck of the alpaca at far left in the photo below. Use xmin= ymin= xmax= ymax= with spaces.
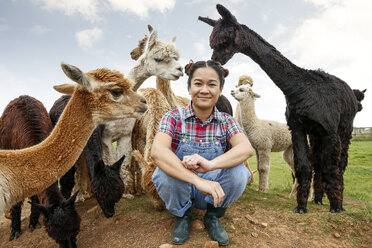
xmin=4 ymin=90 xmax=95 ymax=200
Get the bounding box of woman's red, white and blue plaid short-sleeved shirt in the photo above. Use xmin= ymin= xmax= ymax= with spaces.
xmin=157 ymin=102 xmax=243 ymax=152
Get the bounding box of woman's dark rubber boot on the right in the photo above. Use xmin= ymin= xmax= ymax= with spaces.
xmin=204 ymin=204 xmax=229 ymax=245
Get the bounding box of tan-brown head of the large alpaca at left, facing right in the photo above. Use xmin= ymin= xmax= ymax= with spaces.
xmin=54 ymin=63 xmax=147 ymax=125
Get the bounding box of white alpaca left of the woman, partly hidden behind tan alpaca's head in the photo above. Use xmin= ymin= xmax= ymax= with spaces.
xmin=102 ymin=27 xmax=183 ymax=197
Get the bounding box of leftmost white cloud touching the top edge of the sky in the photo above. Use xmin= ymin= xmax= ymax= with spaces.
xmin=32 ymin=0 xmax=101 ymax=22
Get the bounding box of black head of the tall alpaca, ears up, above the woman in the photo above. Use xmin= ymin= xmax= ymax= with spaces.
xmin=198 ymin=4 xmax=242 ymax=65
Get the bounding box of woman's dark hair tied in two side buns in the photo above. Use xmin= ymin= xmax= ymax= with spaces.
xmin=185 ymin=60 xmax=229 ymax=89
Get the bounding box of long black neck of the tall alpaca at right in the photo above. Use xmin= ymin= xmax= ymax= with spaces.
xmin=240 ymin=25 xmax=304 ymax=96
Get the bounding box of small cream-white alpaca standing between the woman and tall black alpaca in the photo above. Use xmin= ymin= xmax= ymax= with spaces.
xmin=231 ymin=84 xmax=295 ymax=195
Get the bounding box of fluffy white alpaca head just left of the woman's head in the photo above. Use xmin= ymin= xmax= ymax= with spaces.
xmin=137 ymin=28 xmax=183 ymax=80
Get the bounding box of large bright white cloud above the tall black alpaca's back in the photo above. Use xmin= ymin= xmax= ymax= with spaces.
xmin=281 ymin=0 xmax=372 ymax=126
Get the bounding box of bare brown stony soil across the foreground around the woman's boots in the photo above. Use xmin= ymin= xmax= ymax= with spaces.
xmin=0 ymin=189 xmax=372 ymax=248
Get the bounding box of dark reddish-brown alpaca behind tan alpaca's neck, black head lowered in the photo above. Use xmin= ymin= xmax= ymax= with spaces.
xmin=0 ymin=96 xmax=80 ymax=244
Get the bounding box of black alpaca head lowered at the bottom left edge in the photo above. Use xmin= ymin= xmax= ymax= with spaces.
xmin=30 ymin=192 xmax=80 ymax=248
